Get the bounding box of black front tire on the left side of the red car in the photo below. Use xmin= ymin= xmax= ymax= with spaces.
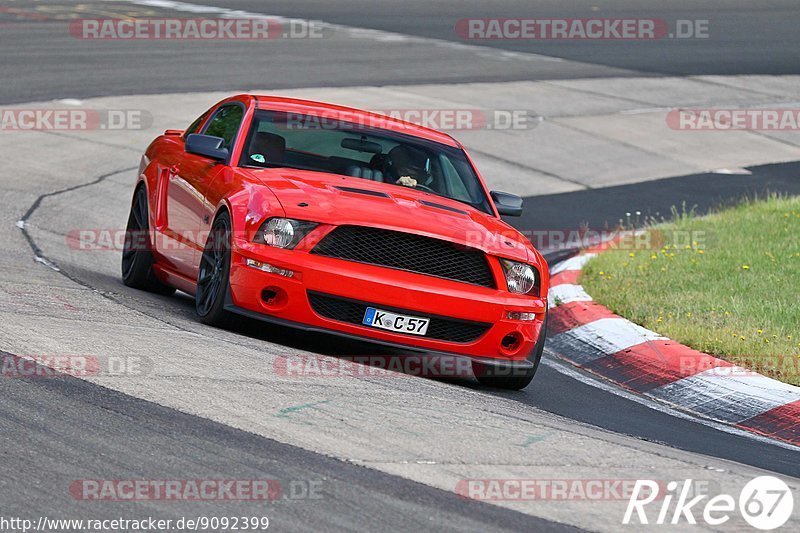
xmin=194 ymin=212 xmax=232 ymax=327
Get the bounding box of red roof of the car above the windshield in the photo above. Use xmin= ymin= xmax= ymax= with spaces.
xmin=248 ymin=95 xmax=461 ymax=148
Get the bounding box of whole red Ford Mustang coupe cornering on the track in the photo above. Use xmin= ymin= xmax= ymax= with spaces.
xmin=122 ymin=95 xmax=548 ymax=389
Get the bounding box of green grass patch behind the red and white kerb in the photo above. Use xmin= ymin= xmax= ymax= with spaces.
xmin=580 ymin=197 xmax=800 ymax=385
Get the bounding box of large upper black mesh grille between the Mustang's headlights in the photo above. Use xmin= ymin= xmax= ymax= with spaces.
xmin=311 ymin=226 xmax=495 ymax=288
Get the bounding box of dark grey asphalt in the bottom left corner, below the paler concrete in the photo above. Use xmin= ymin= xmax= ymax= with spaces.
xmin=0 ymin=354 xmax=573 ymax=532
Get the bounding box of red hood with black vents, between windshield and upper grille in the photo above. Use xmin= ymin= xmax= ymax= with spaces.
xmin=241 ymin=168 xmax=538 ymax=263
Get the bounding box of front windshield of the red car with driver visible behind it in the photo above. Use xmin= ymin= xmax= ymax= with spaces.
xmin=240 ymin=111 xmax=492 ymax=214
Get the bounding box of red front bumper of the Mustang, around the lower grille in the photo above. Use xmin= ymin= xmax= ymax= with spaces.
xmin=226 ymin=240 xmax=547 ymax=367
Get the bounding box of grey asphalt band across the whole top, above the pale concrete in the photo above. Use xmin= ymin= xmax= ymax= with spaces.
xmin=0 ymin=0 xmax=800 ymax=103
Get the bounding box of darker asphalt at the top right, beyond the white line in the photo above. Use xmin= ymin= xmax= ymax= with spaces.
xmin=191 ymin=0 xmax=800 ymax=79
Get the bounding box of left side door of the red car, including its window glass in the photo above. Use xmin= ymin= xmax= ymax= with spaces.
xmin=165 ymin=102 xmax=244 ymax=280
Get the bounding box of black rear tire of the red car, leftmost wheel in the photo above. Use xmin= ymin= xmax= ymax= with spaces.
xmin=121 ymin=186 xmax=175 ymax=296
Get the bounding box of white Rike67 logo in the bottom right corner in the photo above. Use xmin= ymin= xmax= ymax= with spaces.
xmin=622 ymin=476 xmax=794 ymax=531
